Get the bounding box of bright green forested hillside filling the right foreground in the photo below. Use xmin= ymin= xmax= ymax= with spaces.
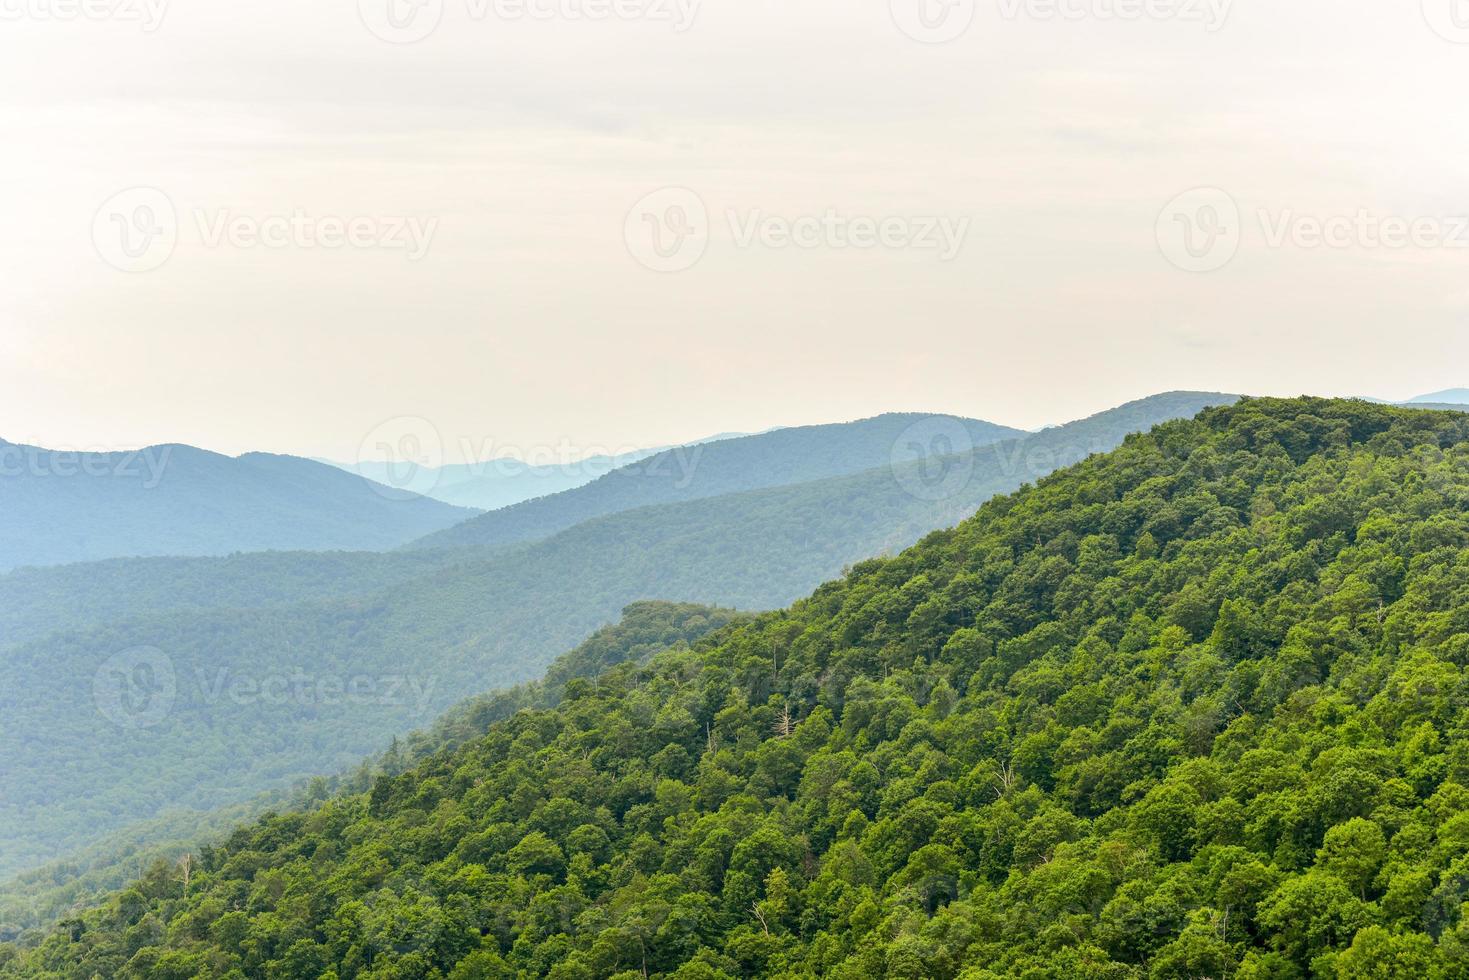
xmin=0 ymin=400 xmax=1469 ymax=980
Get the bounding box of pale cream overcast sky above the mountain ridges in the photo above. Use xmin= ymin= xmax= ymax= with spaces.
xmin=0 ymin=0 xmax=1469 ymax=461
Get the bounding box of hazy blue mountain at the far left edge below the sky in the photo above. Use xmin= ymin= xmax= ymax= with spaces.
xmin=0 ymin=442 xmax=473 ymax=572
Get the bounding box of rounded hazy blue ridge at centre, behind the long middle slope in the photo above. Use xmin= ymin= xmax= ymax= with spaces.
xmin=402 ymin=414 xmax=1025 ymax=548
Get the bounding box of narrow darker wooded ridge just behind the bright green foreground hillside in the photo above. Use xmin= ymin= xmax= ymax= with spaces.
xmin=0 ymin=602 xmax=746 ymax=940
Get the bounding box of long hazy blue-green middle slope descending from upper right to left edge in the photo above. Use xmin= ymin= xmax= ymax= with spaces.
xmin=0 ymin=392 xmax=1228 ymax=874
